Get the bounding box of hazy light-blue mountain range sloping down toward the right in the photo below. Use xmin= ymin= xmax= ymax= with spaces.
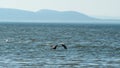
xmin=0 ymin=8 xmax=98 ymax=22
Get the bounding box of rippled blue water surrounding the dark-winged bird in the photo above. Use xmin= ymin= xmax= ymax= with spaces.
xmin=0 ymin=23 xmax=120 ymax=68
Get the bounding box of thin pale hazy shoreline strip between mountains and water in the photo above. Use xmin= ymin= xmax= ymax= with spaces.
xmin=0 ymin=20 xmax=120 ymax=24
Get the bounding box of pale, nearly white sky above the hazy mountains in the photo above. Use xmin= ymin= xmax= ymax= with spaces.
xmin=0 ymin=0 xmax=120 ymax=19
